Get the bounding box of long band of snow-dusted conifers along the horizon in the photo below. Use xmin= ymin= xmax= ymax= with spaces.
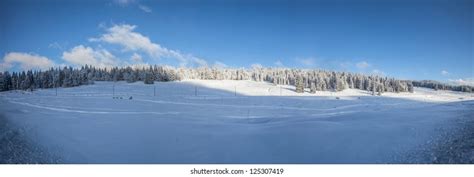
xmin=0 ymin=65 xmax=474 ymax=94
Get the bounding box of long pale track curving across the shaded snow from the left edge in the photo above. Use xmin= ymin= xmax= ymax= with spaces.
xmin=10 ymin=101 xmax=179 ymax=115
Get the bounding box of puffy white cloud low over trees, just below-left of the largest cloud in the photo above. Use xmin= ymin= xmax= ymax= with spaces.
xmin=62 ymin=45 xmax=120 ymax=68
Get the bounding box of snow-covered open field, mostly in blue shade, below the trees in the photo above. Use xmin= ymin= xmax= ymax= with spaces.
xmin=0 ymin=80 xmax=474 ymax=163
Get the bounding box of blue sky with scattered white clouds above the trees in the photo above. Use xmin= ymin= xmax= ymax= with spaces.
xmin=0 ymin=0 xmax=474 ymax=82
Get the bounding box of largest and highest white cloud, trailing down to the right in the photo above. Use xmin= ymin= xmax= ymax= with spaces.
xmin=89 ymin=24 xmax=207 ymax=66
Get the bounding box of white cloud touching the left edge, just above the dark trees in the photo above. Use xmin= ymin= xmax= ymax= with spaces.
xmin=0 ymin=52 xmax=55 ymax=71
